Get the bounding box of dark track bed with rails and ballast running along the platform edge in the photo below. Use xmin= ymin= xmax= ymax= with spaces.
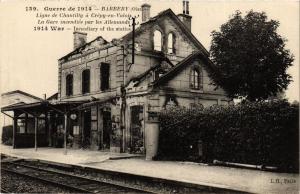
xmin=1 ymin=154 xmax=246 ymax=194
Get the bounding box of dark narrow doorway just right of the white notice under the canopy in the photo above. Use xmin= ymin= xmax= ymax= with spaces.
xmin=82 ymin=110 xmax=91 ymax=148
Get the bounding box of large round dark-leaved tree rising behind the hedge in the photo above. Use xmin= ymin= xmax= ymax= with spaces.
xmin=210 ymin=10 xmax=294 ymax=101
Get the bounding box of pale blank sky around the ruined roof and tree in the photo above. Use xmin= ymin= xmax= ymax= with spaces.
xmin=0 ymin=0 xmax=299 ymax=102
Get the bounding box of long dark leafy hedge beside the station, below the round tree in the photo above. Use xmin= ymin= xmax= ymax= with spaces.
xmin=158 ymin=100 xmax=299 ymax=171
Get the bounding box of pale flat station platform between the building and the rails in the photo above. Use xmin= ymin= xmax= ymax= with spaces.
xmin=1 ymin=145 xmax=299 ymax=194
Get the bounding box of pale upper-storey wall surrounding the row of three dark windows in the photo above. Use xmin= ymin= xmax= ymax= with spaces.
xmin=60 ymin=46 xmax=123 ymax=100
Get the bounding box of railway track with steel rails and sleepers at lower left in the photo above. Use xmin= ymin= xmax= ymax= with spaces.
xmin=1 ymin=161 xmax=149 ymax=193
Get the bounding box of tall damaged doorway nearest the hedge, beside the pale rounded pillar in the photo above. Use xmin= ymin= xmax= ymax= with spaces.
xmin=130 ymin=105 xmax=145 ymax=154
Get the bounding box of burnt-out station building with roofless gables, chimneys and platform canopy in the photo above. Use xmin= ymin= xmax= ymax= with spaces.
xmin=2 ymin=3 xmax=231 ymax=157
